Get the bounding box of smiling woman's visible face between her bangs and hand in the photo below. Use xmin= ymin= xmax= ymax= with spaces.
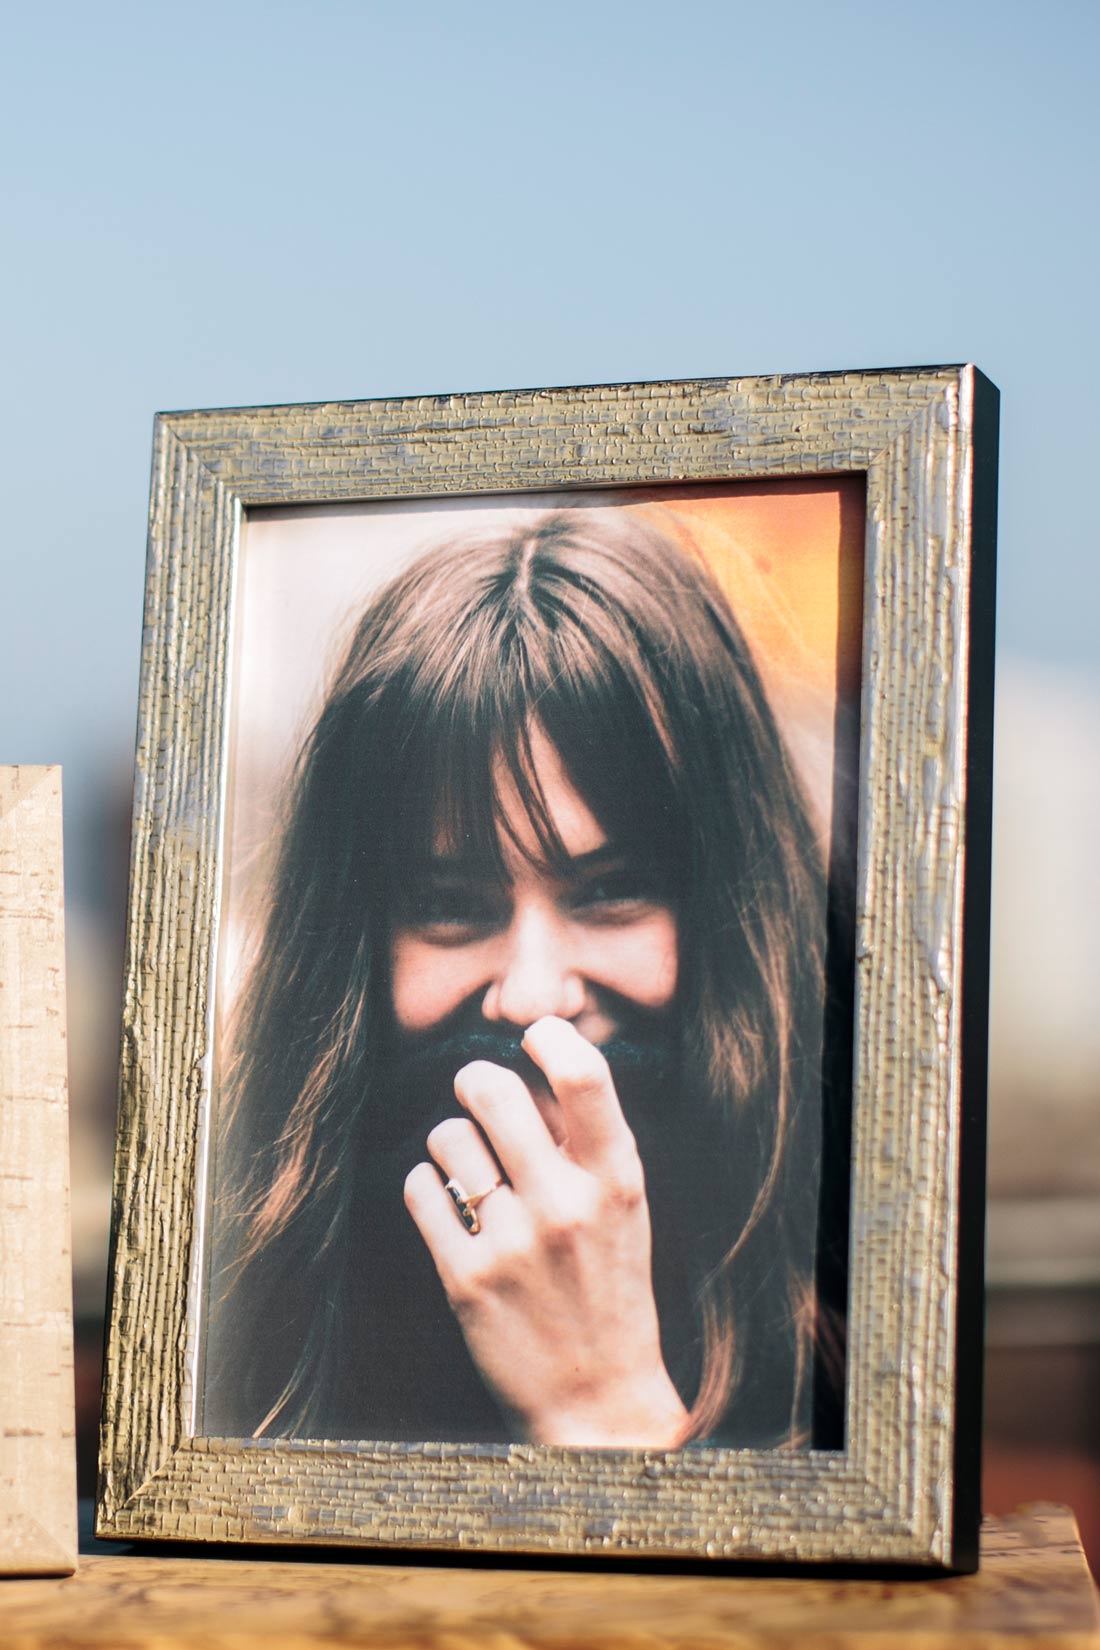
xmin=391 ymin=728 xmax=678 ymax=1043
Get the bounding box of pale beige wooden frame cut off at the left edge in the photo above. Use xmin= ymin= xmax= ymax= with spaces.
xmin=0 ymin=767 xmax=76 ymax=1577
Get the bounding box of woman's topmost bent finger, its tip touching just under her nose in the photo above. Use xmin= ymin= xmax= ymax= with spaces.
xmin=523 ymin=1015 xmax=635 ymax=1168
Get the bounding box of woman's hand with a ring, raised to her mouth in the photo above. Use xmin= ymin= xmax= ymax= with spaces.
xmin=406 ymin=1018 xmax=686 ymax=1449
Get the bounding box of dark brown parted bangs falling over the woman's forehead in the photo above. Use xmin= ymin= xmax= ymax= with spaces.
xmin=386 ymin=590 xmax=678 ymax=888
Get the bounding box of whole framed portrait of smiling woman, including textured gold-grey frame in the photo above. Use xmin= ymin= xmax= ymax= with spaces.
xmin=97 ymin=368 xmax=996 ymax=1569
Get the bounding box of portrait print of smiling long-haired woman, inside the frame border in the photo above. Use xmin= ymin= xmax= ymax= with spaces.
xmin=200 ymin=475 xmax=864 ymax=1449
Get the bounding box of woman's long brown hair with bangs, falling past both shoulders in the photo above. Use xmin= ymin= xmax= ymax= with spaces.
xmin=208 ymin=508 xmax=848 ymax=1444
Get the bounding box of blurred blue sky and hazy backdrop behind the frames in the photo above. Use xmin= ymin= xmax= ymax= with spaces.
xmin=0 ymin=0 xmax=1100 ymax=1568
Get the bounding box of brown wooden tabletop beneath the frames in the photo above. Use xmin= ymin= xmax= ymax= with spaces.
xmin=0 ymin=1506 xmax=1100 ymax=1650
